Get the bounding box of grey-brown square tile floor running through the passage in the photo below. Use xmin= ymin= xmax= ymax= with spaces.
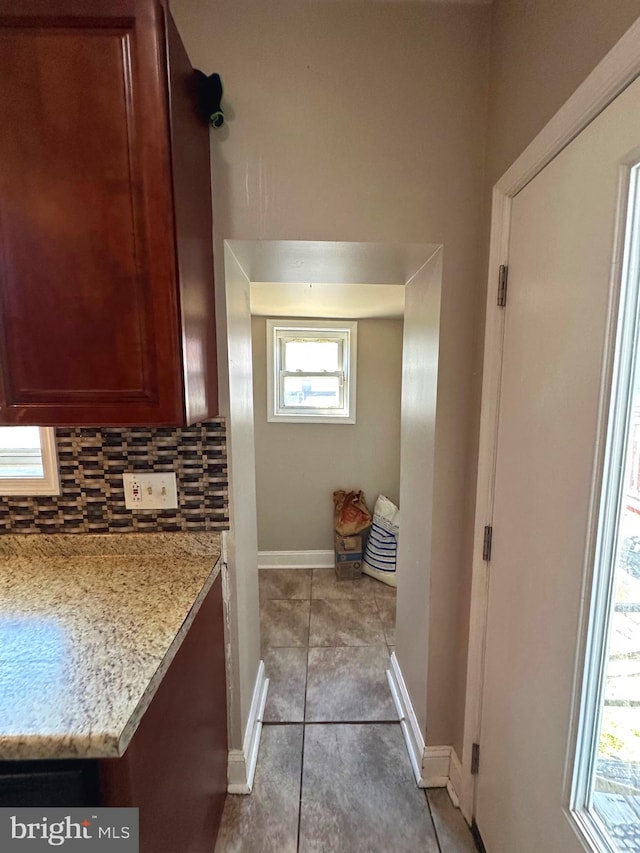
xmin=216 ymin=569 xmax=476 ymax=853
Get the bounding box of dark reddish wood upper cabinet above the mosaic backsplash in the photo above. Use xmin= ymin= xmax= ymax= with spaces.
xmin=0 ymin=0 xmax=217 ymax=426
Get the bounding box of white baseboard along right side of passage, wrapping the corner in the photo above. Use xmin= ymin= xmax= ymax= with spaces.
xmin=387 ymin=652 xmax=463 ymax=808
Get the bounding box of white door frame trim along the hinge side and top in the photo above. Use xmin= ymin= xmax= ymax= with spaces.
xmin=458 ymin=19 xmax=640 ymax=823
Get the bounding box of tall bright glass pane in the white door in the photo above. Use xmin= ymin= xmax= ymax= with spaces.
xmin=585 ymin=167 xmax=640 ymax=853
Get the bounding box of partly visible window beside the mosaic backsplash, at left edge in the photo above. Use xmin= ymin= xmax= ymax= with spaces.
xmin=0 ymin=426 xmax=60 ymax=495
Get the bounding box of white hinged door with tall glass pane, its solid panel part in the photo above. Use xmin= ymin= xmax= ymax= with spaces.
xmin=475 ymin=76 xmax=640 ymax=853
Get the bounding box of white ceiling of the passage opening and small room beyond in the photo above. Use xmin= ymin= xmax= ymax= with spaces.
xmin=228 ymin=240 xmax=438 ymax=319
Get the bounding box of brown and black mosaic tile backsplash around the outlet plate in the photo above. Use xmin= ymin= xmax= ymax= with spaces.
xmin=0 ymin=418 xmax=229 ymax=534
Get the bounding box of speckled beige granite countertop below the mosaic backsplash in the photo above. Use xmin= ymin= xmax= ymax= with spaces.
xmin=0 ymin=533 xmax=220 ymax=760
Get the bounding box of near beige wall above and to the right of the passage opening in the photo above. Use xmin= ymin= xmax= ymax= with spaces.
xmin=171 ymin=0 xmax=490 ymax=744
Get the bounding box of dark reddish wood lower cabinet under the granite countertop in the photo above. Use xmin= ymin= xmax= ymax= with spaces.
xmin=0 ymin=576 xmax=227 ymax=853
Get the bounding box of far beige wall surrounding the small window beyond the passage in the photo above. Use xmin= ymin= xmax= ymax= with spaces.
xmin=251 ymin=317 xmax=402 ymax=551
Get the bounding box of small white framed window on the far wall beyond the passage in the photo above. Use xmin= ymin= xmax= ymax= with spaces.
xmin=267 ymin=320 xmax=358 ymax=424
